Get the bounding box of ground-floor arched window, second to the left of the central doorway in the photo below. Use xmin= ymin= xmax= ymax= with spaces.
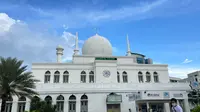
xmin=68 ymin=95 xmax=76 ymax=112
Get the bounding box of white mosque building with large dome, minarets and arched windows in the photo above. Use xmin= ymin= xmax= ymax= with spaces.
xmin=0 ymin=34 xmax=190 ymax=112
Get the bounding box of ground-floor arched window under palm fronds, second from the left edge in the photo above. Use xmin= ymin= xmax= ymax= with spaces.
xmin=17 ymin=96 xmax=26 ymax=112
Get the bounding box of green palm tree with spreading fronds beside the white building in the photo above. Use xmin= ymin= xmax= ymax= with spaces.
xmin=0 ymin=57 xmax=39 ymax=112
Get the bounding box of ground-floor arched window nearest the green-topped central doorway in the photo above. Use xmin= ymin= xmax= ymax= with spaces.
xmin=81 ymin=95 xmax=88 ymax=112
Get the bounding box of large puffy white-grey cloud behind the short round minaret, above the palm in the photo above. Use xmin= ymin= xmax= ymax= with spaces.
xmin=0 ymin=13 xmax=83 ymax=64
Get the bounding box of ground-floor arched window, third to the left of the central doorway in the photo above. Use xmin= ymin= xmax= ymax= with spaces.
xmin=56 ymin=95 xmax=65 ymax=112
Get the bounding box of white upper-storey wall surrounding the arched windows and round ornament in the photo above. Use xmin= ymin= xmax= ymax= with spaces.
xmin=32 ymin=61 xmax=169 ymax=83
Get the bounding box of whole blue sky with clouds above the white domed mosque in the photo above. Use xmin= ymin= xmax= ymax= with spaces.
xmin=0 ymin=0 xmax=200 ymax=78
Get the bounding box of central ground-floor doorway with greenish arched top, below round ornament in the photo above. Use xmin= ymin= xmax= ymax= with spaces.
xmin=106 ymin=93 xmax=122 ymax=112
